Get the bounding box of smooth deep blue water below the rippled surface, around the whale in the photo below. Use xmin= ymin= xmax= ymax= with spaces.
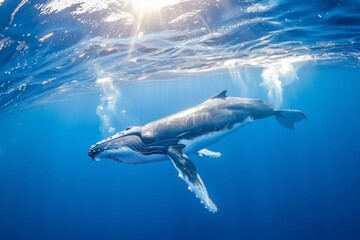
xmin=0 ymin=67 xmax=360 ymax=239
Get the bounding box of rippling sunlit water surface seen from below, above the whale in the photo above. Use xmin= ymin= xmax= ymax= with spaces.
xmin=0 ymin=0 xmax=360 ymax=111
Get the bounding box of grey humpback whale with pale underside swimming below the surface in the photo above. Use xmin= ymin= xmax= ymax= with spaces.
xmin=88 ymin=90 xmax=306 ymax=212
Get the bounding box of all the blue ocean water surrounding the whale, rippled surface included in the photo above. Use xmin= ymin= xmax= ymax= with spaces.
xmin=0 ymin=0 xmax=360 ymax=239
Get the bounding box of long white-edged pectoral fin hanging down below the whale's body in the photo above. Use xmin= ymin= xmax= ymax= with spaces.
xmin=168 ymin=145 xmax=218 ymax=212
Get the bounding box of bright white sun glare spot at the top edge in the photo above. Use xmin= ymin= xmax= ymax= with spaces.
xmin=129 ymin=0 xmax=181 ymax=12
